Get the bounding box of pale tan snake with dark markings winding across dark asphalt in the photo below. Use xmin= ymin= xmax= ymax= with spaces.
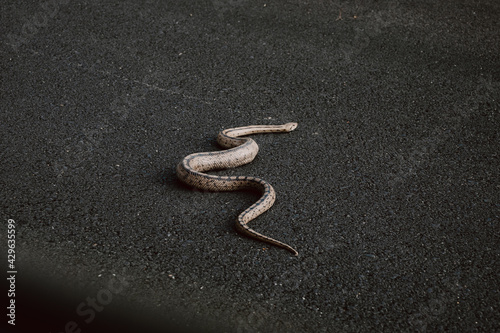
xmin=176 ymin=123 xmax=298 ymax=256
